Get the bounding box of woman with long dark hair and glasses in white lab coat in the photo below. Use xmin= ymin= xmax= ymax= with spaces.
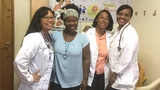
xmin=14 ymin=7 xmax=55 ymax=90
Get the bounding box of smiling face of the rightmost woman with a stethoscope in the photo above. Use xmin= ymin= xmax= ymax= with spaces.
xmin=117 ymin=9 xmax=132 ymax=28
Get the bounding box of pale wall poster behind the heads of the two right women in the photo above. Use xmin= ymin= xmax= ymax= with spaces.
xmin=74 ymin=0 xmax=131 ymax=22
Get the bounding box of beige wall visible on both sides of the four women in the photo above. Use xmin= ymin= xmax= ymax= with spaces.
xmin=14 ymin=0 xmax=160 ymax=90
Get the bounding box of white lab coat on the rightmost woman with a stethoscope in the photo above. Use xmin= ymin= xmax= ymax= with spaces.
xmin=109 ymin=23 xmax=139 ymax=90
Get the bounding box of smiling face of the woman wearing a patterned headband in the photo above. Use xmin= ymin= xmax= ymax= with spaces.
xmin=64 ymin=16 xmax=78 ymax=32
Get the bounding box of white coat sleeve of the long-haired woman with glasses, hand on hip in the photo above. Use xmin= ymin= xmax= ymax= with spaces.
xmin=13 ymin=35 xmax=40 ymax=85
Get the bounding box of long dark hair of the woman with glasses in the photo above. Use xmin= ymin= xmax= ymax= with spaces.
xmin=25 ymin=6 xmax=54 ymax=36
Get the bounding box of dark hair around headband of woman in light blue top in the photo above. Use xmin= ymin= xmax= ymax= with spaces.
xmin=60 ymin=4 xmax=80 ymax=20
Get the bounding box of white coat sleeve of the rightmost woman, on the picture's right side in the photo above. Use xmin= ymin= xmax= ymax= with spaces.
xmin=115 ymin=28 xmax=139 ymax=74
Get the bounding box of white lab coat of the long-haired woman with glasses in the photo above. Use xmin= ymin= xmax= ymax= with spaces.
xmin=14 ymin=32 xmax=54 ymax=90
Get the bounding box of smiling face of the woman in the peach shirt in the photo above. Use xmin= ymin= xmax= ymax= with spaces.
xmin=96 ymin=12 xmax=109 ymax=30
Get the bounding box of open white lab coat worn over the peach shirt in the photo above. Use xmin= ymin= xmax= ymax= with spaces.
xmin=85 ymin=28 xmax=111 ymax=88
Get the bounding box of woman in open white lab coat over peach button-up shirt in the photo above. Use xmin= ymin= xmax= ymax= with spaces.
xmin=85 ymin=10 xmax=113 ymax=90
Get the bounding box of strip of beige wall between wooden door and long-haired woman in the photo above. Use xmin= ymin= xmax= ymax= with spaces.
xmin=14 ymin=0 xmax=30 ymax=90
